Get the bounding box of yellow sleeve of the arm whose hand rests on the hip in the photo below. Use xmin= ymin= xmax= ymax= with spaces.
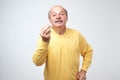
xmin=80 ymin=33 xmax=93 ymax=71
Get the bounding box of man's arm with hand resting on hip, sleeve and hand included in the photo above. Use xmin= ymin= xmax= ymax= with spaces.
xmin=77 ymin=32 xmax=93 ymax=80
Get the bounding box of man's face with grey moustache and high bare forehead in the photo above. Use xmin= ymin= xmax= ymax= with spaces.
xmin=49 ymin=6 xmax=68 ymax=27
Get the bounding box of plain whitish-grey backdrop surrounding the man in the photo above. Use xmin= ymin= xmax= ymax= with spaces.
xmin=0 ymin=0 xmax=120 ymax=80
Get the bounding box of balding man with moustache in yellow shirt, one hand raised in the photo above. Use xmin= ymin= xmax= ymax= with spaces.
xmin=33 ymin=5 xmax=92 ymax=80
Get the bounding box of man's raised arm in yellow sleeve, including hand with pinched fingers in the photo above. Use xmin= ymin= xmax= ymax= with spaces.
xmin=32 ymin=25 xmax=51 ymax=66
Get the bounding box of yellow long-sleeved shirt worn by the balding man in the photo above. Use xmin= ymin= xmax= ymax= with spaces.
xmin=33 ymin=28 xmax=92 ymax=80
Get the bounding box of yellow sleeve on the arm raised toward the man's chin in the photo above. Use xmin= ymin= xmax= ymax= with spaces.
xmin=32 ymin=37 xmax=48 ymax=66
